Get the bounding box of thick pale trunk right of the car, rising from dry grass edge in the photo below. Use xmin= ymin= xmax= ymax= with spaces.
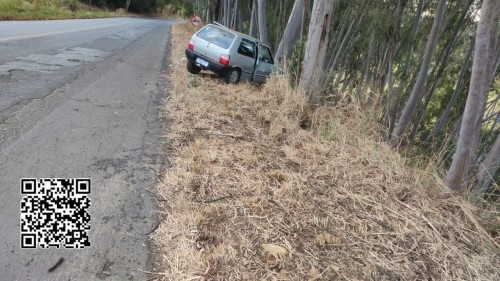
xmin=300 ymin=0 xmax=333 ymax=105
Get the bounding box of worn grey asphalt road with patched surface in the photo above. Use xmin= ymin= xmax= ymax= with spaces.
xmin=0 ymin=18 xmax=180 ymax=280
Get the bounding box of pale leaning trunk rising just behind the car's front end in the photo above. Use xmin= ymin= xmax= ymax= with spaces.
xmin=274 ymin=0 xmax=304 ymax=61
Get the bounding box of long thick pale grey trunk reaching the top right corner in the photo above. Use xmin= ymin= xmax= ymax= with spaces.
xmin=446 ymin=0 xmax=500 ymax=193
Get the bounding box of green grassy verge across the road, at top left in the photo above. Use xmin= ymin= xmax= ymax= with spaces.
xmin=0 ymin=0 xmax=117 ymax=20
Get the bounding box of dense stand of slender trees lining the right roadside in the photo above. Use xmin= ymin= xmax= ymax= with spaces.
xmin=167 ymin=0 xmax=500 ymax=206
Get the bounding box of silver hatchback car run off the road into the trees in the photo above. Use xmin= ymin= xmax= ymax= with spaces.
xmin=186 ymin=22 xmax=275 ymax=84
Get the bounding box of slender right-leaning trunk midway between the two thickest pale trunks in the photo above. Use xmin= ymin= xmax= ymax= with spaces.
xmin=391 ymin=0 xmax=446 ymax=143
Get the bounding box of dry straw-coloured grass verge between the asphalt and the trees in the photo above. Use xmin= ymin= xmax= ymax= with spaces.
xmin=152 ymin=25 xmax=500 ymax=280
